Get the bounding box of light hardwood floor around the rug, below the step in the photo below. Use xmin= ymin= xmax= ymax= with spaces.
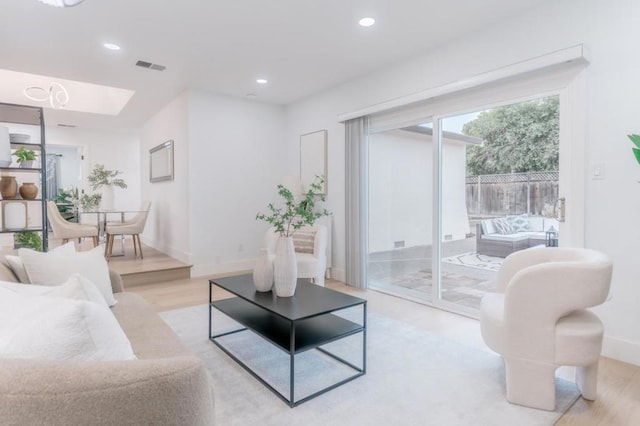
xmin=127 ymin=277 xmax=640 ymax=426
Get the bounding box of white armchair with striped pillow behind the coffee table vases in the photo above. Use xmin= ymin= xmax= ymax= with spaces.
xmin=264 ymin=224 xmax=327 ymax=287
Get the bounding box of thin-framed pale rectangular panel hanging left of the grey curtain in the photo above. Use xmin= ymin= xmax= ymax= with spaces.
xmin=300 ymin=130 xmax=327 ymax=194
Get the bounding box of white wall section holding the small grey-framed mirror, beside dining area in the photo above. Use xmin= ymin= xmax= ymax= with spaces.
xmin=139 ymin=92 xmax=191 ymax=263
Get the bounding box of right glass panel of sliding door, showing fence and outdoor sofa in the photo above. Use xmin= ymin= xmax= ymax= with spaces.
xmin=434 ymin=96 xmax=559 ymax=313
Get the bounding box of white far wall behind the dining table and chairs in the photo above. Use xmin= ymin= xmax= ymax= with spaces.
xmin=45 ymin=126 xmax=140 ymax=210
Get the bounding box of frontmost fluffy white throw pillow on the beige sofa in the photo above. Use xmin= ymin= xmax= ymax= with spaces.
xmin=0 ymin=288 xmax=136 ymax=361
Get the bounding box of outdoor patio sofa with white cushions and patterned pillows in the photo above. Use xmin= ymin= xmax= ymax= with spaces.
xmin=476 ymin=214 xmax=559 ymax=257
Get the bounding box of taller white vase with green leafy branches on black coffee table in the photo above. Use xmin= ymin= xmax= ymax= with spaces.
xmin=256 ymin=176 xmax=330 ymax=297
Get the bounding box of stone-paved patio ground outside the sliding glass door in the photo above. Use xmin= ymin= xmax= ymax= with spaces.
xmin=368 ymin=236 xmax=502 ymax=309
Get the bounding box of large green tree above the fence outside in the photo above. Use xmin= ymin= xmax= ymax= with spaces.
xmin=462 ymin=96 xmax=560 ymax=176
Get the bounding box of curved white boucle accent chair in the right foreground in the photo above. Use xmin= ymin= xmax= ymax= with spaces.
xmin=480 ymin=247 xmax=613 ymax=410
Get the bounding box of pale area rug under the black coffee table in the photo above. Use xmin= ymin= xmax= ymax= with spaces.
xmin=161 ymin=305 xmax=578 ymax=426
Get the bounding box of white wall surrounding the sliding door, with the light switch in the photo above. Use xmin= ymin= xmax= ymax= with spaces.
xmin=286 ymin=0 xmax=640 ymax=364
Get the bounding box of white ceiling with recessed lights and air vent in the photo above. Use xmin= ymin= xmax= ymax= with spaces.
xmin=0 ymin=0 xmax=549 ymax=128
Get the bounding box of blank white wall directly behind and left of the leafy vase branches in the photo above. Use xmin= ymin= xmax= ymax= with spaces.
xmin=188 ymin=91 xmax=287 ymax=275
